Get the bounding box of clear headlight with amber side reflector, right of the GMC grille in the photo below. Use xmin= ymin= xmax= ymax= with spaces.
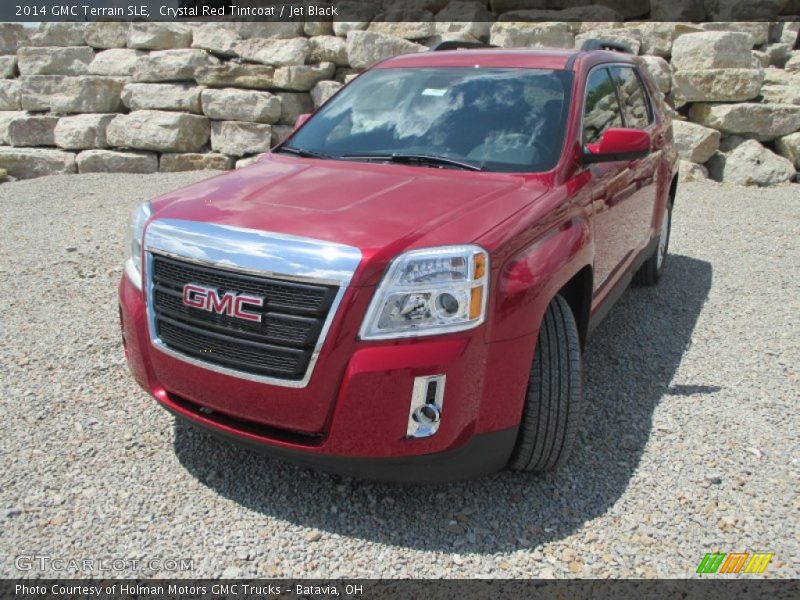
xmin=359 ymin=246 xmax=489 ymax=340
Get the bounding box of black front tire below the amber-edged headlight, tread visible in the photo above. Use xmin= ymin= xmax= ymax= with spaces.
xmin=509 ymin=296 xmax=582 ymax=472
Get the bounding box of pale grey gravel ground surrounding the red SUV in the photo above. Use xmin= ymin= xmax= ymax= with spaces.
xmin=0 ymin=173 xmax=800 ymax=577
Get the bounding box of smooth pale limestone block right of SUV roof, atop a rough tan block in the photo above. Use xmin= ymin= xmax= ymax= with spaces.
xmin=672 ymin=31 xmax=753 ymax=71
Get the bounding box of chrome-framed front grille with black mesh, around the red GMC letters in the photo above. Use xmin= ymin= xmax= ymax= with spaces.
xmin=145 ymin=219 xmax=361 ymax=387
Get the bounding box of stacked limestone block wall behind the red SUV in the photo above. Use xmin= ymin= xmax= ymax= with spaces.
xmin=0 ymin=16 xmax=800 ymax=185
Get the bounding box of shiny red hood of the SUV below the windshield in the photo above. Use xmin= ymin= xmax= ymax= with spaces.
xmin=153 ymin=154 xmax=546 ymax=284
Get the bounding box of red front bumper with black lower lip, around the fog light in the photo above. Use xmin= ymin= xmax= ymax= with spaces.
xmin=119 ymin=276 xmax=536 ymax=481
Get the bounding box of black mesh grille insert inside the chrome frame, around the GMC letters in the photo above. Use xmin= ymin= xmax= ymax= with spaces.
xmin=152 ymin=254 xmax=338 ymax=380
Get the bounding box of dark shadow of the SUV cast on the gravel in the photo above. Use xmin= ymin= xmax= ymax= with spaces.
xmin=174 ymin=255 xmax=718 ymax=554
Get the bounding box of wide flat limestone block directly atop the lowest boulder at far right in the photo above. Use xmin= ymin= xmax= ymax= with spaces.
xmin=689 ymin=102 xmax=800 ymax=141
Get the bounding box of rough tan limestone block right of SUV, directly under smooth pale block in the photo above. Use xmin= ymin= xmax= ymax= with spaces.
xmin=672 ymin=69 xmax=764 ymax=106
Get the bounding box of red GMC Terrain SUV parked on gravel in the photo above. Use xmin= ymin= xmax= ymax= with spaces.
xmin=119 ymin=42 xmax=677 ymax=481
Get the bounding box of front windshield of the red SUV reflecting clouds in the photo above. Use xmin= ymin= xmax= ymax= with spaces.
xmin=287 ymin=67 xmax=572 ymax=172
